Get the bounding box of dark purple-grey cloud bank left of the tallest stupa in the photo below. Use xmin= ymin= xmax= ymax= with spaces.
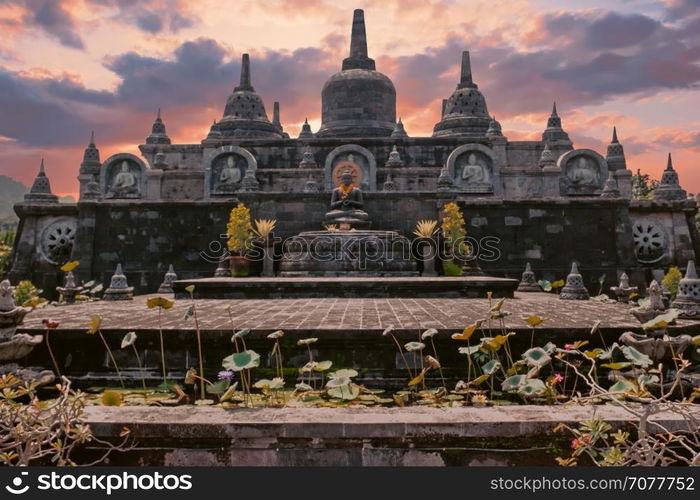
xmin=0 ymin=38 xmax=337 ymax=146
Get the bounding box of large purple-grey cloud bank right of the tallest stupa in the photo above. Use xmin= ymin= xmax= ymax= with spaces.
xmin=388 ymin=5 xmax=700 ymax=116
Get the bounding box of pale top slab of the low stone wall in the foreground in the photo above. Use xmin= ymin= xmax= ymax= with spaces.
xmin=86 ymin=405 xmax=700 ymax=440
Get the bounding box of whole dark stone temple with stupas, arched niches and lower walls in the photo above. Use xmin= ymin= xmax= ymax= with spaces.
xmin=10 ymin=10 xmax=700 ymax=293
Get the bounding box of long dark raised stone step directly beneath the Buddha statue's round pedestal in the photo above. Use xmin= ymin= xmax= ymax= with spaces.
xmin=173 ymin=276 xmax=518 ymax=299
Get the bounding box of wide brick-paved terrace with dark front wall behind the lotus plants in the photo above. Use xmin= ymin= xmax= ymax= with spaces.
xmin=19 ymin=292 xmax=700 ymax=388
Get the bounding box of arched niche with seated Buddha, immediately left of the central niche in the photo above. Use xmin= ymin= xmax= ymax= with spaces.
xmin=204 ymin=146 xmax=258 ymax=198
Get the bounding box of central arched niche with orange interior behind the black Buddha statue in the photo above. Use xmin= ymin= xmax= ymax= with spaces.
xmin=324 ymin=144 xmax=377 ymax=191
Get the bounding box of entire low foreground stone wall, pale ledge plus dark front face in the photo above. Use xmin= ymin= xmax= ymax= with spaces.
xmin=86 ymin=405 xmax=700 ymax=466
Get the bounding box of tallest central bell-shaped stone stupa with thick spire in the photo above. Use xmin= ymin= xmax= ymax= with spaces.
xmin=316 ymin=9 xmax=396 ymax=137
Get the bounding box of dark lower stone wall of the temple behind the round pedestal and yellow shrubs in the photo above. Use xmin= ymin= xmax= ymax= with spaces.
xmin=64 ymin=193 xmax=638 ymax=292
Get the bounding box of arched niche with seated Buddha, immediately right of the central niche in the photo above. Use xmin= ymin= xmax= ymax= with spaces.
xmin=446 ymin=144 xmax=500 ymax=194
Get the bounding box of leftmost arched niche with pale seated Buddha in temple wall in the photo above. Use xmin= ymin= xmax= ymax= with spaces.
xmin=100 ymin=153 xmax=149 ymax=200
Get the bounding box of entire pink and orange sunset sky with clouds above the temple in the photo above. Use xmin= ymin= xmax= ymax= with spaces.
xmin=0 ymin=0 xmax=700 ymax=194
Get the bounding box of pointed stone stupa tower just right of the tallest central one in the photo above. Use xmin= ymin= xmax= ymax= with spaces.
xmin=433 ymin=50 xmax=491 ymax=137
